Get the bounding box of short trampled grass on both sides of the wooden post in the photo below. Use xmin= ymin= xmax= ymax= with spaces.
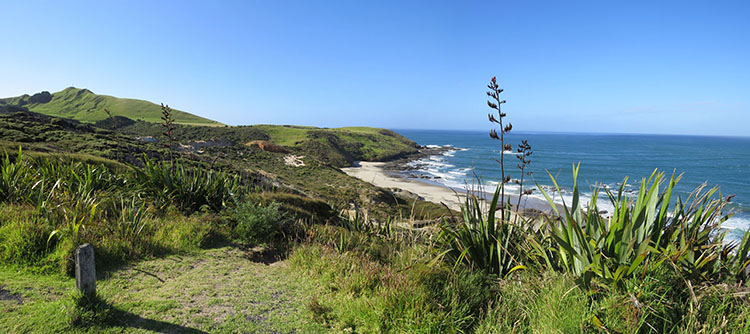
xmin=0 ymin=247 xmax=326 ymax=333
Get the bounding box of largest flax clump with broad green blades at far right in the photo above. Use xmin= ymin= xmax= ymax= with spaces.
xmin=537 ymin=166 xmax=750 ymax=287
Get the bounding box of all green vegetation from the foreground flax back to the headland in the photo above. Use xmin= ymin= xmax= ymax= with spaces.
xmin=0 ymin=82 xmax=750 ymax=333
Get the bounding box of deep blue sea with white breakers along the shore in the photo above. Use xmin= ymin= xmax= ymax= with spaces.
xmin=395 ymin=130 xmax=750 ymax=240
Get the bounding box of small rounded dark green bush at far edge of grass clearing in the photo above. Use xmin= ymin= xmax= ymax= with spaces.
xmin=232 ymin=202 xmax=286 ymax=245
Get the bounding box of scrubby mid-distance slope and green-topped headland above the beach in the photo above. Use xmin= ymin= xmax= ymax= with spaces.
xmin=0 ymin=110 xmax=445 ymax=219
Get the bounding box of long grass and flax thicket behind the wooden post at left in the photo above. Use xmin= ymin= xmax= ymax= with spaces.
xmin=0 ymin=149 xmax=242 ymax=273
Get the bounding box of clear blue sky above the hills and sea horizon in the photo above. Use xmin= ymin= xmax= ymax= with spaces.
xmin=0 ymin=0 xmax=750 ymax=136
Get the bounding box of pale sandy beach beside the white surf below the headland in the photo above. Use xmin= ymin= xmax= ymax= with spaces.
xmin=341 ymin=161 xmax=468 ymax=211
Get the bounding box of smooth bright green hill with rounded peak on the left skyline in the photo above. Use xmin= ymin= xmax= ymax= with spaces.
xmin=0 ymin=87 xmax=223 ymax=126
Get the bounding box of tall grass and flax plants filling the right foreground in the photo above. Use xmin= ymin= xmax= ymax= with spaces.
xmin=282 ymin=171 xmax=750 ymax=333
